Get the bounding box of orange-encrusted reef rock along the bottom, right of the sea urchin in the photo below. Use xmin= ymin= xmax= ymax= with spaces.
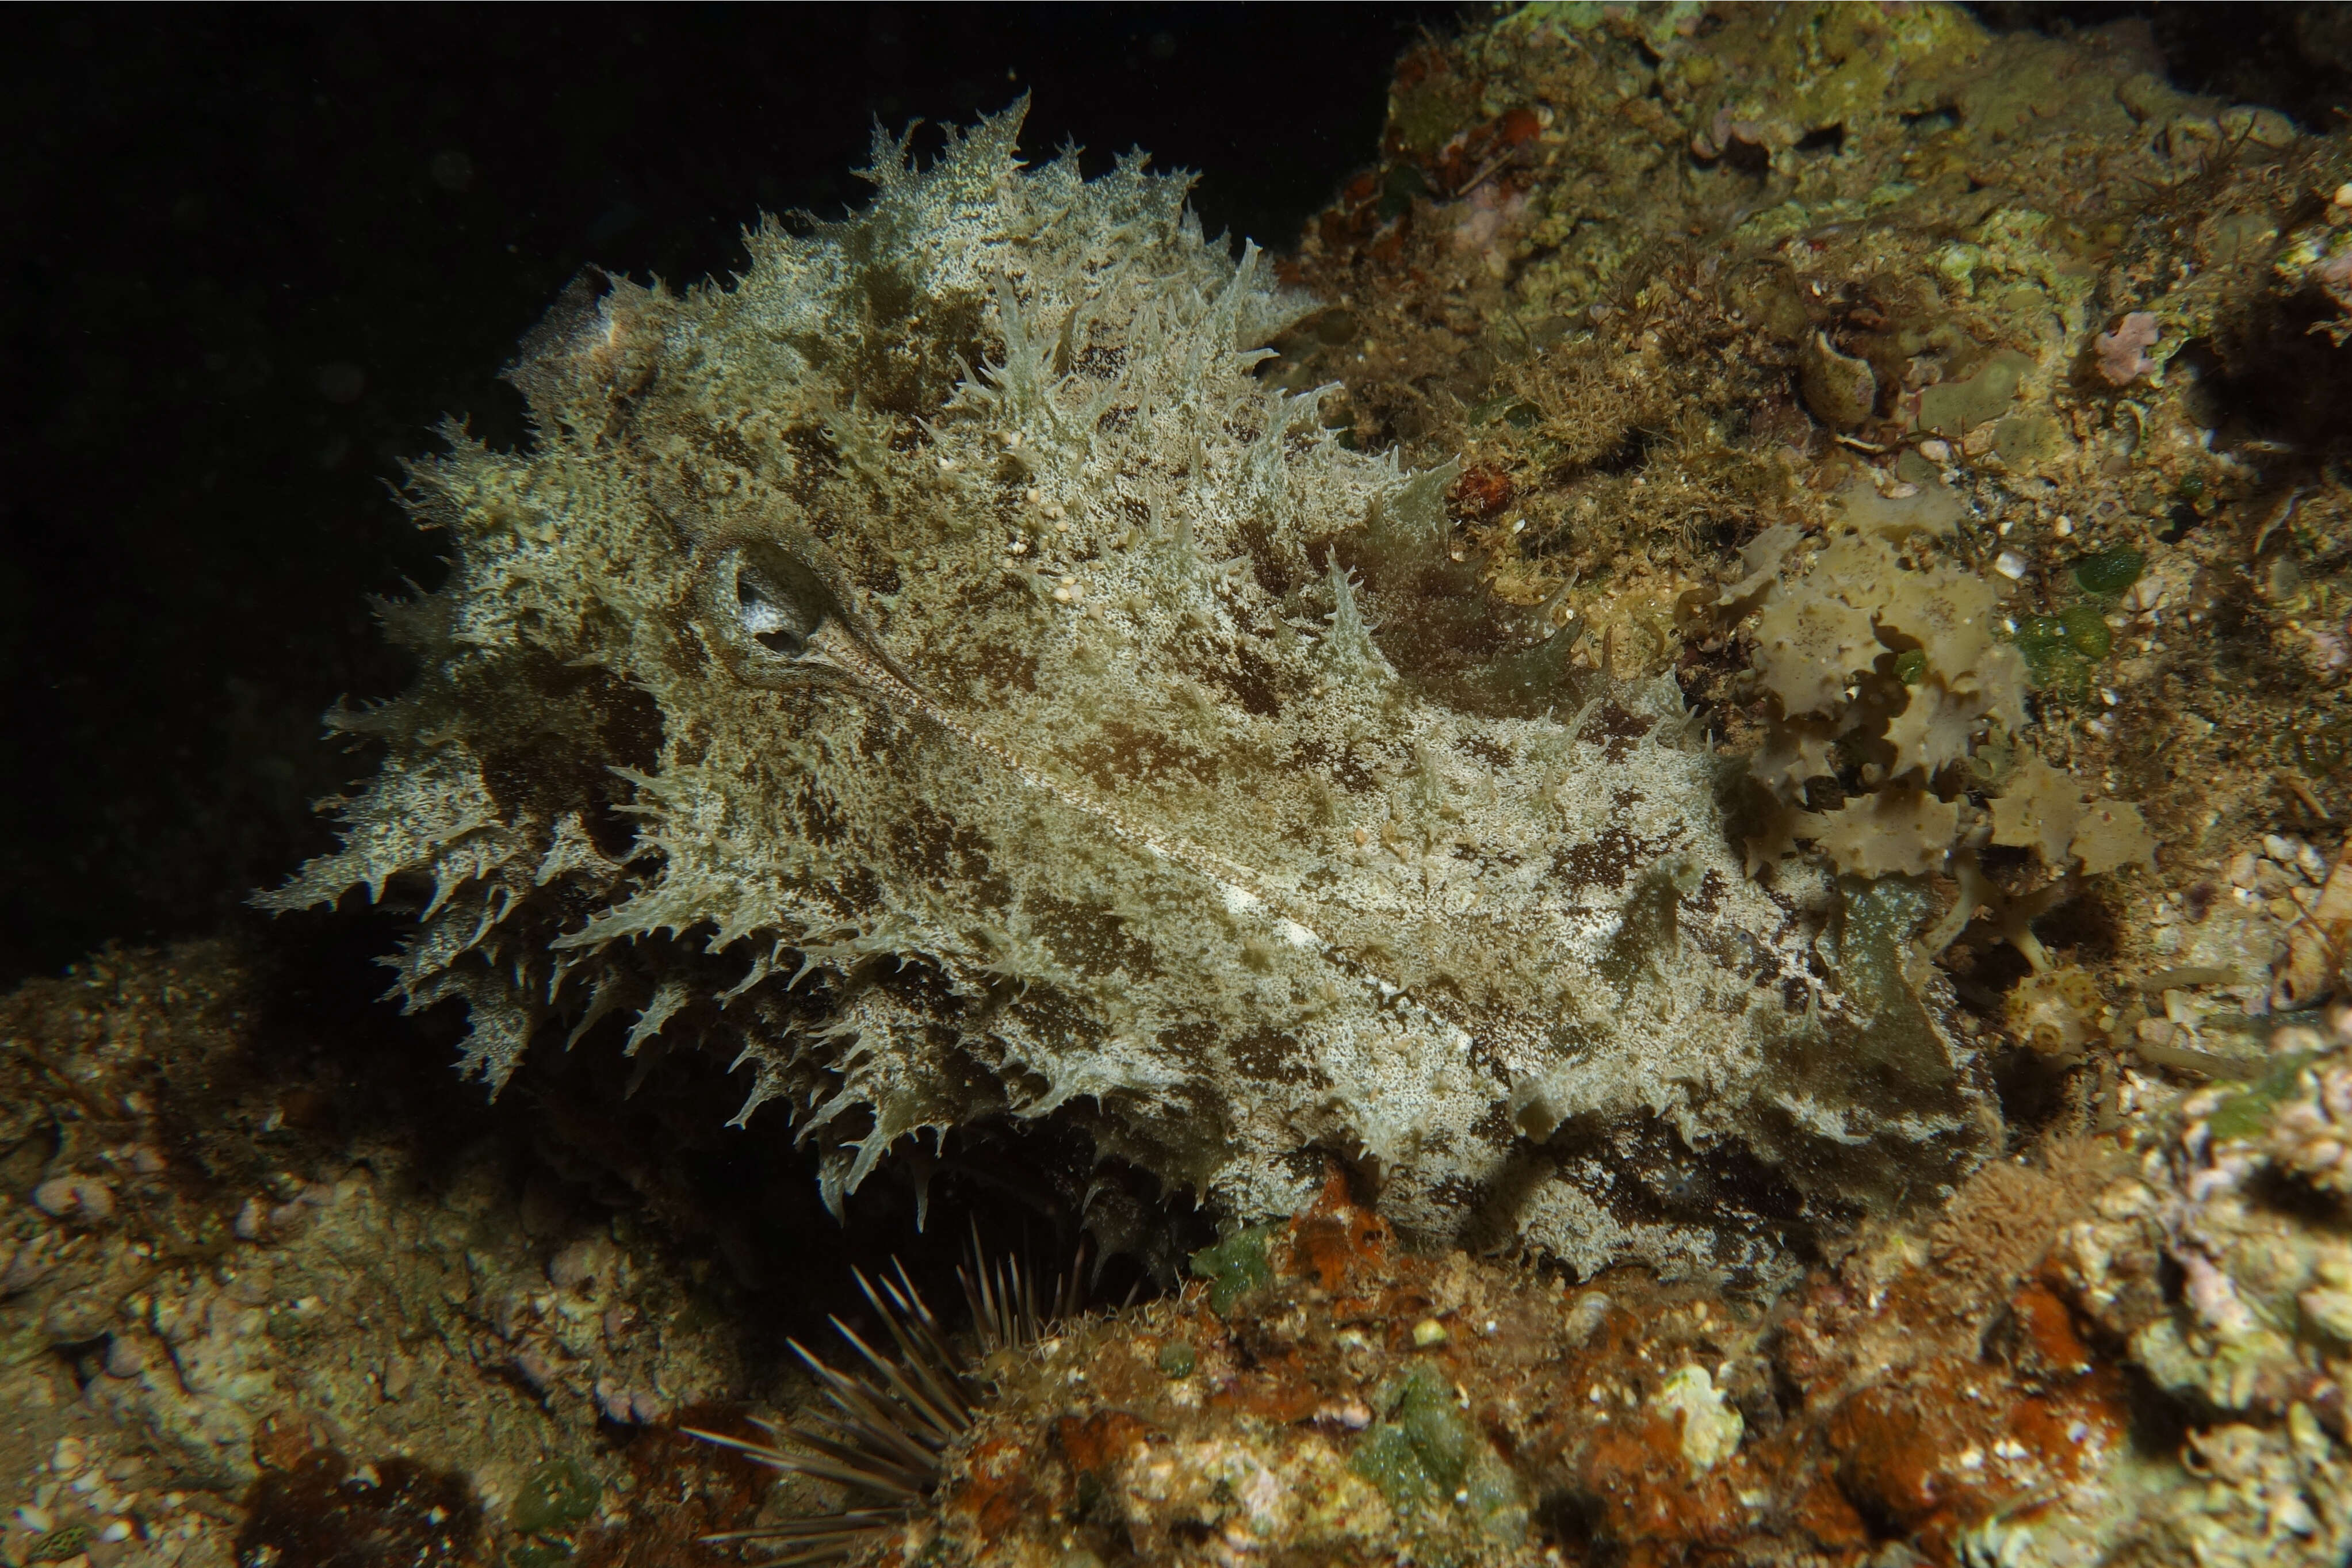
xmin=889 ymin=1011 xmax=2352 ymax=1568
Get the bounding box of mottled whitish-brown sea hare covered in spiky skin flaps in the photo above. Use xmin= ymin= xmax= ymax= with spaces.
xmin=261 ymin=110 xmax=1997 ymax=1276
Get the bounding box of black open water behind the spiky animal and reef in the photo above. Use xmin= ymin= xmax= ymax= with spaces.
xmin=0 ymin=5 xmax=2343 ymax=985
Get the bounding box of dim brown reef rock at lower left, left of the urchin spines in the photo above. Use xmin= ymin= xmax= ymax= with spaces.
xmin=0 ymin=940 xmax=762 ymax=1568
